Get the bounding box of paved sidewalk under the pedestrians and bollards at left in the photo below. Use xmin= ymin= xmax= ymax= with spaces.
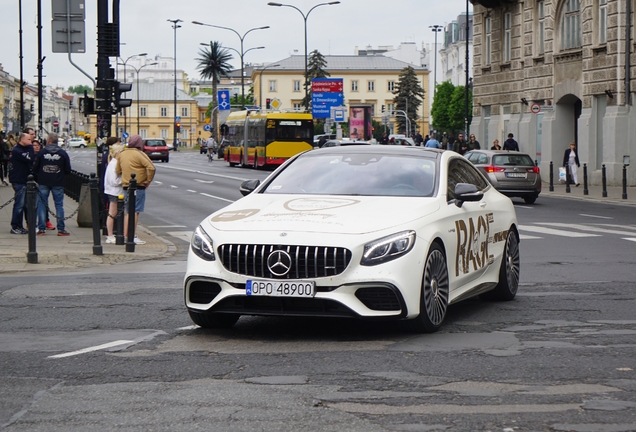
xmin=0 ymin=186 xmax=175 ymax=274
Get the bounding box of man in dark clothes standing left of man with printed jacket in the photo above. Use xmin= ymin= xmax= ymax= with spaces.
xmin=9 ymin=132 xmax=33 ymax=234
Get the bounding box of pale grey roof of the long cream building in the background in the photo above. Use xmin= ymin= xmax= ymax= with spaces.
xmin=254 ymin=55 xmax=428 ymax=72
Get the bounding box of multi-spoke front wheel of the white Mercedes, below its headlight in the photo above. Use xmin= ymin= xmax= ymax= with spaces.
xmin=407 ymin=243 xmax=450 ymax=333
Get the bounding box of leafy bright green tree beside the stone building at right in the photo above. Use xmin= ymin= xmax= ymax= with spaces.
xmin=431 ymin=81 xmax=472 ymax=134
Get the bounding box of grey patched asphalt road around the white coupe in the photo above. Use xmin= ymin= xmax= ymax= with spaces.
xmin=0 ymin=149 xmax=636 ymax=432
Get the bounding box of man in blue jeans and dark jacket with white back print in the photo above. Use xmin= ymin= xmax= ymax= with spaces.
xmin=33 ymin=132 xmax=71 ymax=237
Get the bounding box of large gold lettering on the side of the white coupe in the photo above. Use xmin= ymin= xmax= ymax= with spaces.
xmin=455 ymin=213 xmax=493 ymax=276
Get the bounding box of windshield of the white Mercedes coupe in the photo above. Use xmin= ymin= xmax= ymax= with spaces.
xmin=263 ymin=153 xmax=436 ymax=197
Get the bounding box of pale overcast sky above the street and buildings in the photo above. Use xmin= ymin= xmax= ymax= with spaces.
xmin=0 ymin=0 xmax=472 ymax=88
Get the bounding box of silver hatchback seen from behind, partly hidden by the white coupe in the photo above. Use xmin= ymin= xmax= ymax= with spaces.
xmin=464 ymin=150 xmax=541 ymax=204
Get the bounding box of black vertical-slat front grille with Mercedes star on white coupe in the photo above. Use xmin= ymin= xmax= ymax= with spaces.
xmin=217 ymin=244 xmax=351 ymax=279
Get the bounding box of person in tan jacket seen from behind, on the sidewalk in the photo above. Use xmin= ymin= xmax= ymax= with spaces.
xmin=115 ymin=135 xmax=155 ymax=245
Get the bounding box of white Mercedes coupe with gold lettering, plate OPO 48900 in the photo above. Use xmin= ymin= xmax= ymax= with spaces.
xmin=184 ymin=145 xmax=520 ymax=332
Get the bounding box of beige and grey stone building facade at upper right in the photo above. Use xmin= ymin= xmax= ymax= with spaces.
xmin=471 ymin=0 xmax=636 ymax=185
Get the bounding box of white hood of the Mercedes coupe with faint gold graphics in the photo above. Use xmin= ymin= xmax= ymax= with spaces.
xmin=206 ymin=194 xmax=439 ymax=234
